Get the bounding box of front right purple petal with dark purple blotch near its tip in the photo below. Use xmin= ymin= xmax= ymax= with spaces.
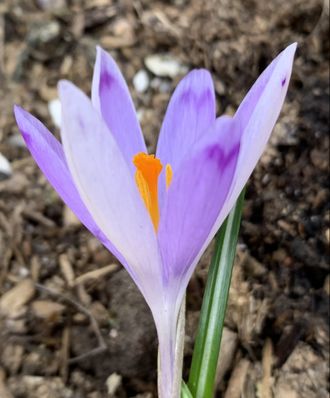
xmin=158 ymin=116 xmax=240 ymax=292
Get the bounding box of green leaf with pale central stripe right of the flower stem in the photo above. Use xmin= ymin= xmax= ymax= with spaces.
xmin=188 ymin=190 xmax=245 ymax=398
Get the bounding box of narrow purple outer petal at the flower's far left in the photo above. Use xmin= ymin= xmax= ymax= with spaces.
xmin=14 ymin=105 xmax=142 ymax=286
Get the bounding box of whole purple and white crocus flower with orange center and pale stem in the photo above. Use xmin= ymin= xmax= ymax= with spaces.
xmin=14 ymin=44 xmax=296 ymax=398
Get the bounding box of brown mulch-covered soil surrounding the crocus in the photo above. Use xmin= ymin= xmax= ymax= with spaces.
xmin=0 ymin=0 xmax=330 ymax=398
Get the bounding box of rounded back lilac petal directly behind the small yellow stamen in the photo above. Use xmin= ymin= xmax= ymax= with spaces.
xmin=156 ymin=69 xmax=216 ymax=172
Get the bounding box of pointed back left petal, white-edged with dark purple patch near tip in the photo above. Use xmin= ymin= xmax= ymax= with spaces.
xmin=92 ymin=47 xmax=147 ymax=174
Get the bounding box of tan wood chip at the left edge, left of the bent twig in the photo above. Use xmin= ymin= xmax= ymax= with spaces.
xmin=0 ymin=279 xmax=35 ymax=316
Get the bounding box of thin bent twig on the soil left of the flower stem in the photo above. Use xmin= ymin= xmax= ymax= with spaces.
xmin=35 ymin=283 xmax=107 ymax=365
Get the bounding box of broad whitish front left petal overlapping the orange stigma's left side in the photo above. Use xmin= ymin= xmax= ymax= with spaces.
xmin=59 ymin=81 xmax=161 ymax=305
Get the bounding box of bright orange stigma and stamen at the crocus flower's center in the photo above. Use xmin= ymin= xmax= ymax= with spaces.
xmin=133 ymin=152 xmax=173 ymax=232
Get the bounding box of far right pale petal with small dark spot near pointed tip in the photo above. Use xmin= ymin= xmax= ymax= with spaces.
xmin=182 ymin=43 xmax=297 ymax=290
